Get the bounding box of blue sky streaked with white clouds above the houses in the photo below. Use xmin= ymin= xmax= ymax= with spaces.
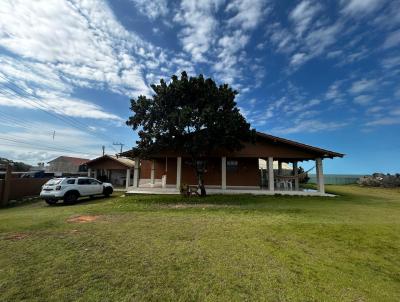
xmin=0 ymin=0 xmax=400 ymax=174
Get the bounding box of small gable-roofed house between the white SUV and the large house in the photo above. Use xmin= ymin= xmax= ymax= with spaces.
xmin=86 ymin=155 xmax=135 ymax=186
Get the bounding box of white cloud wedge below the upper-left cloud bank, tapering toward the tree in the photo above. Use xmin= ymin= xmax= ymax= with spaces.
xmin=0 ymin=55 xmax=122 ymax=122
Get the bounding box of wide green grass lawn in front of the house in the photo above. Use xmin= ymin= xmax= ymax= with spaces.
xmin=0 ymin=186 xmax=400 ymax=301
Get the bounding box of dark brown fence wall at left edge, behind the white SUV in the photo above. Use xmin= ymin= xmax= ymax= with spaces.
xmin=0 ymin=168 xmax=50 ymax=205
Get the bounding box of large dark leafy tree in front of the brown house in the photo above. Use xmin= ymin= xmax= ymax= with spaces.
xmin=126 ymin=72 xmax=255 ymax=196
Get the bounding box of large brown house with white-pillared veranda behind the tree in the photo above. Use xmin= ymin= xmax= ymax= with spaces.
xmin=121 ymin=132 xmax=344 ymax=195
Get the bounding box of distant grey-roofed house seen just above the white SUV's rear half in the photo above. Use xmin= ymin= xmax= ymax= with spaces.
xmin=46 ymin=156 xmax=89 ymax=176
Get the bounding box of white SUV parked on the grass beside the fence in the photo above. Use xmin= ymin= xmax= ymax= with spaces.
xmin=40 ymin=177 xmax=114 ymax=205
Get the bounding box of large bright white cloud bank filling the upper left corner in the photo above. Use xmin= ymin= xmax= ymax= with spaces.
xmin=0 ymin=0 xmax=159 ymax=95
